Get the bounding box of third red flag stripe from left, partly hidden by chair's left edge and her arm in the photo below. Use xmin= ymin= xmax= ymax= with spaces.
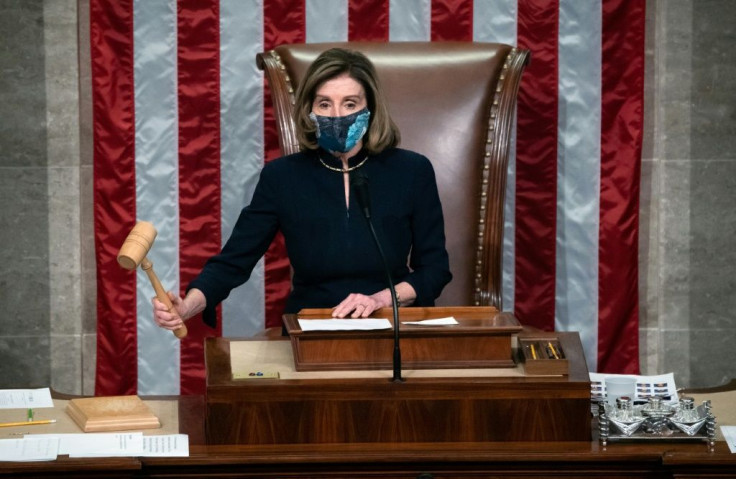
xmin=263 ymin=0 xmax=306 ymax=328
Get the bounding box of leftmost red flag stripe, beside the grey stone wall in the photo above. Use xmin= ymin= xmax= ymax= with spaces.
xmin=90 ymin=0 xmax=138 ymax=396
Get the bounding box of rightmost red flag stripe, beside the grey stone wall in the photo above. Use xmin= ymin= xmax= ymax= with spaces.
xmin=598 ymin=0 xmax=645 ymax=374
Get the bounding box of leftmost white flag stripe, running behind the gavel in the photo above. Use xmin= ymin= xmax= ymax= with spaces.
xmin=133 ymin=0 xmax=179 ymax=395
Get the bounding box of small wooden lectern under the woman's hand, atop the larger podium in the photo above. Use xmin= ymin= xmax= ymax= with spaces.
xmin=284 ymin=306 xmax=522 ymax=371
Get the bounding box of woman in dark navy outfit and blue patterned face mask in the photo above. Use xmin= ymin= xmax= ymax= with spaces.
xmin=153 ymin=48 xmax=452 ymax=330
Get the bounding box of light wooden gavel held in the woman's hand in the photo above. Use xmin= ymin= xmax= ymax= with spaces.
xmin=118 ymin=221 xmax=187 ymax=339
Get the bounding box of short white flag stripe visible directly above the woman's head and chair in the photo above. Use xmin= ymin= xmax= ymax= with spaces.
xmin=304 ymin=0 xmax=348 ymax=43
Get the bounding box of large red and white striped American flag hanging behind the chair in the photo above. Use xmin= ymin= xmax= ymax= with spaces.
xmin=90 ymin=0 xmax=645 ymax=395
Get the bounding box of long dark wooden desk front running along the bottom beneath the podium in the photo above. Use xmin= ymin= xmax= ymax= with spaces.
xmin=0 ymin=393 xmax=736 ymax=479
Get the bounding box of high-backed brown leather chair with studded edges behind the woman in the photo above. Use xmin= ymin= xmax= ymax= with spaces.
xmin=257 ymin=42 xmax=529 ymax=309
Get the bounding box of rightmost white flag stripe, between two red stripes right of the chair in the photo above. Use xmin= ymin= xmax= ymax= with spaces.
xmin=555 ymin=0 xmax=602 ymax=371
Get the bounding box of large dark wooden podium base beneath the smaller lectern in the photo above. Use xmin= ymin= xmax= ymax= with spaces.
xmin=205 ymin=308 xmax=591 ymax=444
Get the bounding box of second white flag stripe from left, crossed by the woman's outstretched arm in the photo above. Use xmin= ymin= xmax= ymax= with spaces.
xmin=220 ymin=0 xmax=265 ymax=337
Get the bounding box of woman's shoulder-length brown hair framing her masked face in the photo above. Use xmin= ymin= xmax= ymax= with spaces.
xmin=294 ymin=48 xmax=401 ymax=154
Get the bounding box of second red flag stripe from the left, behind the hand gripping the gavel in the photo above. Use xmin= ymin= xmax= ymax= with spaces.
xmin=177 ymin=0 xmax=222 ymax=394
